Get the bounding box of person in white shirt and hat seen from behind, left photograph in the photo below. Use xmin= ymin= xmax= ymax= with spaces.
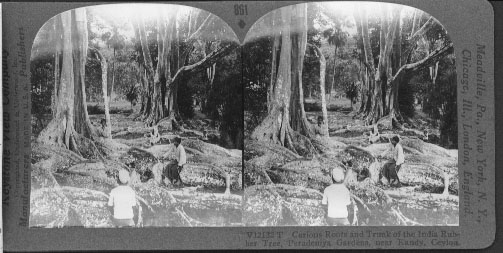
xmin=108 ymin=170 xmax=138 ymax=227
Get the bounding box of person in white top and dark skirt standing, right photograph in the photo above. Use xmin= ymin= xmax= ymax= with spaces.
xmin=379 ymin=136 xmax=405 ymax=187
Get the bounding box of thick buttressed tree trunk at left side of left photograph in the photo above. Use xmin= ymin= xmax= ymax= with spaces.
xmin=38 ymin=9 xmax=101 ymax=158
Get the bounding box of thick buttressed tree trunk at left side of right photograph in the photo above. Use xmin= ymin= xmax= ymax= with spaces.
xmin=251 ymin=4 xmax=315 ymax=155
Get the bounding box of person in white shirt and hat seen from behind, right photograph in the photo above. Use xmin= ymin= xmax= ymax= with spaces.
xmin=321 ymin=169 xmax=351 ymax=226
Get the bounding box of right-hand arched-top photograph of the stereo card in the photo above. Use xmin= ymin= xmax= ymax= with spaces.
xmin=241 ymin=2 xmax=459 ymax=226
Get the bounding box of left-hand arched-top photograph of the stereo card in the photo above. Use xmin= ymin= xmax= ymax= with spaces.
xmin=29 ymin=4 xmax=243 ymax=228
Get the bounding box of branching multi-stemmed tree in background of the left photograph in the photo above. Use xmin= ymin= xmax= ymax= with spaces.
xmin=136 ymin=9 xmax=230 ymax=125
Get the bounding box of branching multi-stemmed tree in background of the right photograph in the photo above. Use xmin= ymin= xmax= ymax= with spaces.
xmin=355 ymin=7 xmax=452 ymax=124
